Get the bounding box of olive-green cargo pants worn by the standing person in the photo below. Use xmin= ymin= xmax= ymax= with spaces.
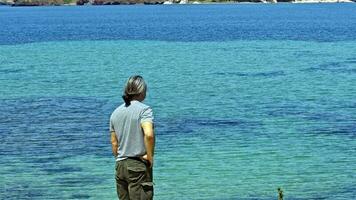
xmin=115 ymin=158 xmax=153 ymax=200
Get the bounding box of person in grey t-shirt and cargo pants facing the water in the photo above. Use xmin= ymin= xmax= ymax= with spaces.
xmin=110 ymin=76 xmax=155 ymax=200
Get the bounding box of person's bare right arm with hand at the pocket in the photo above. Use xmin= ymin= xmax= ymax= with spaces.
xmin=141 ymin=122 xmax=155 ymax=167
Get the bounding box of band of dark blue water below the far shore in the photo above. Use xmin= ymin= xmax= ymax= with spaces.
xmin=0 ymin=4 xmax=356 ymax=44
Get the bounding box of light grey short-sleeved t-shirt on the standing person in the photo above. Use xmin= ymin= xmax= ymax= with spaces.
xmin=110 ymin=100 xmax=153 ymax=161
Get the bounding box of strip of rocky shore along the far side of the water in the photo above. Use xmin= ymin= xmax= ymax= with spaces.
xmin=0 ymin=0 xmax=356 ymax=6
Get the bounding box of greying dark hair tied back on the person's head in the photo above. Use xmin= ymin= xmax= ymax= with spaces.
xmin=122 ymin=75 xmax=147 ymax=106
